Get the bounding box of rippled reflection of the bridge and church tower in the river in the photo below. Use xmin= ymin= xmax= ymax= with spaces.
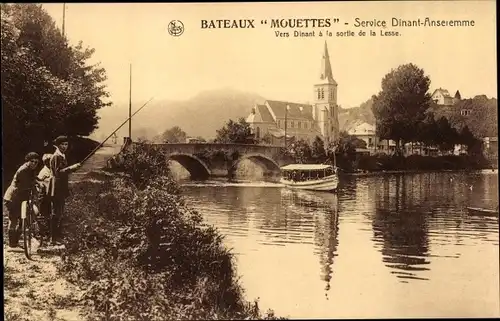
xmin=184 ymin=186 xmax=338 ymax=290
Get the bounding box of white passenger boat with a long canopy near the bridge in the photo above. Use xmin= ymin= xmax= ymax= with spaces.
xmin=280 ymin=164 xmax=339 ymax=191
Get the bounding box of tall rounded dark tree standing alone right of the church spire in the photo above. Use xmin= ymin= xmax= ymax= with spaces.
xmin=373 ymin=63 xmax=431 ymax=154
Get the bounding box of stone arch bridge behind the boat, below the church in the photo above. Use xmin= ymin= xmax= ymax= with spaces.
xmin=134 ymin=143 xmax=292 ymax=180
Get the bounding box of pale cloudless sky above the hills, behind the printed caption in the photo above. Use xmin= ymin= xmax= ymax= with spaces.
xmin=43 ymin=0 xmax=497 ymax=107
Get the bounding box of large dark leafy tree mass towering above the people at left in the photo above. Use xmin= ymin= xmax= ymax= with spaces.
xmin=1 ymin=4 xmax=110 ymax=185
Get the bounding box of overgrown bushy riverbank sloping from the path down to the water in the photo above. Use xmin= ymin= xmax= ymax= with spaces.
xmin=60 ymin=147 xmax=286 ymax=320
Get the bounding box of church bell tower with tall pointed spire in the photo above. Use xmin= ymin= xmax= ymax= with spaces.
xmin=314 ymin=41 xmax=339 ymax=146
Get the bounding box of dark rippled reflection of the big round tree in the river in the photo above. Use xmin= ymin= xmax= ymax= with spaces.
xmin=372 ymin=175 xmax=430 ymax=282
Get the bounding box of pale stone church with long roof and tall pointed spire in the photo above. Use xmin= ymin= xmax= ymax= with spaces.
xmin=246 ymin=41 xmax=339 ymax=145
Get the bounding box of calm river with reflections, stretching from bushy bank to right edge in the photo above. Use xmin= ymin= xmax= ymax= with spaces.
xmin=179 ymin=172 xmax=500 ymax=318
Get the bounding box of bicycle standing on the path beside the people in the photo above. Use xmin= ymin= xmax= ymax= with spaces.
xmin=21 ymin=188 xmax=43 ymax=260
